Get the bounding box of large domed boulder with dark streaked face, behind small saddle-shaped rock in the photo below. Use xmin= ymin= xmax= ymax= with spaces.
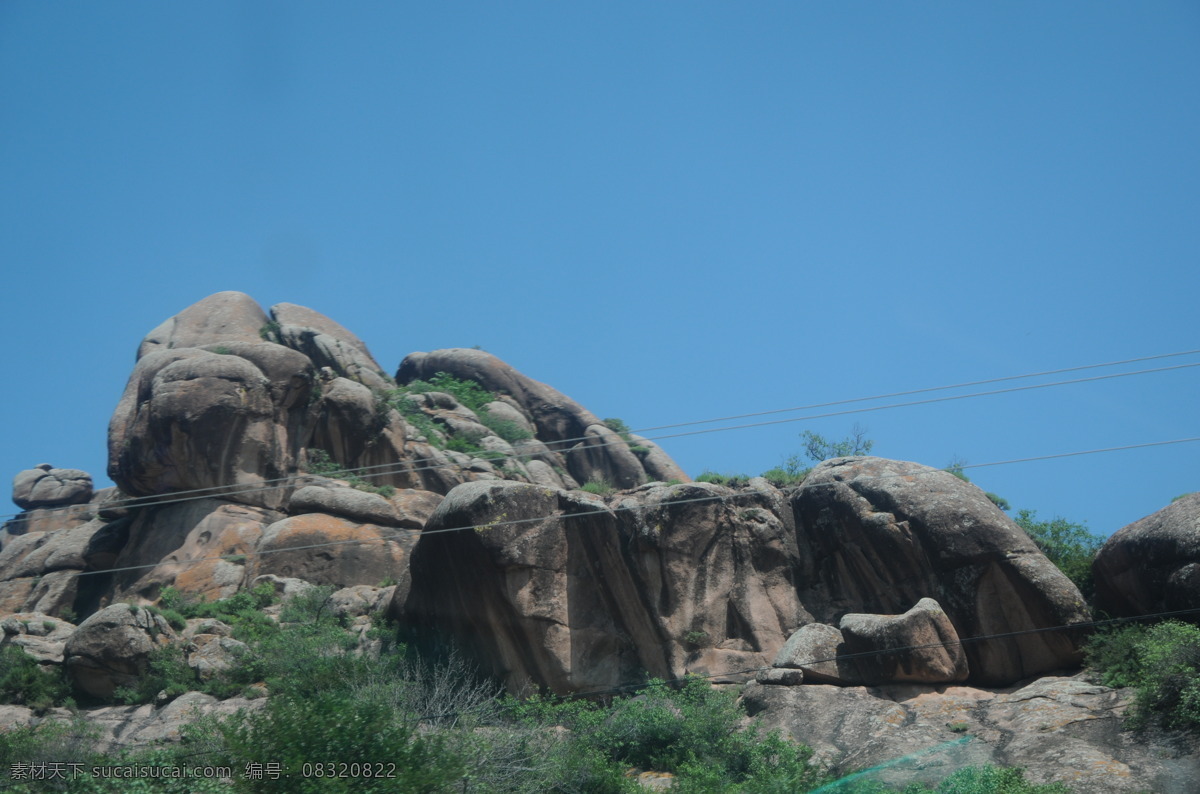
xmin=792 ymin=457 xmax=1090 ymax=684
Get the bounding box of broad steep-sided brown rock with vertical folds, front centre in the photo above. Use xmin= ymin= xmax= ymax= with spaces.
xmin=403 ymin=482 xmax=804 ymax=692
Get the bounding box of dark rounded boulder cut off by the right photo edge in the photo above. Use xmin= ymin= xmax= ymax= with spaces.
xmin=1092 ymin=493 xmax=1200 ymax=616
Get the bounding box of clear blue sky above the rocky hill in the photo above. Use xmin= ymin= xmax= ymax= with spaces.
xmin=0 ymin=0 xmax=1200 ymax=535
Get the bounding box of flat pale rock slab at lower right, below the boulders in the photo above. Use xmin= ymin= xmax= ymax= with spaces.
xmin=743 ymin=675 xmax=1200 ymax=794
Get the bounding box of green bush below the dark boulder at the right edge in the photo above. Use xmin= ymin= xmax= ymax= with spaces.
xmin=1084 ymin=620 xmax=1200 ymax=732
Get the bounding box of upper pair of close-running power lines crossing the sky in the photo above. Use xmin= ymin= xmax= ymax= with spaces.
xmin=0 ymin=350 xmax=1200 ymax=518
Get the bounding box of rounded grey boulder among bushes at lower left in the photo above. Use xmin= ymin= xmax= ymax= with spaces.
xmin=64 ymin=603 xmax=175 ymax=698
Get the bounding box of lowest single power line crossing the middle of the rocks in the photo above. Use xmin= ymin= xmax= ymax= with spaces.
xmin=56 ymin=437 xmax=1200 ymax=576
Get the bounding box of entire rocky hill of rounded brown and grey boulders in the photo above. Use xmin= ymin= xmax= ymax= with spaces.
xmin=0 ymin=293 xmax=1200 ymax=792
